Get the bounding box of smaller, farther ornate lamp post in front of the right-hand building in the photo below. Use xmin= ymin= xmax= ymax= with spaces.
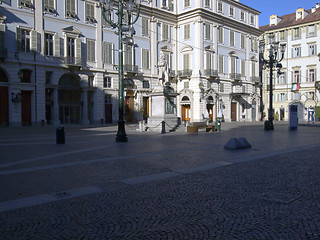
xmin=259 ymin=34 xmax=286 ymax=130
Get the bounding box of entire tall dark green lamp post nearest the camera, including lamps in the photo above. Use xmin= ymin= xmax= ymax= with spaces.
xmin=100 ymin=0 xmax=141 ymax=142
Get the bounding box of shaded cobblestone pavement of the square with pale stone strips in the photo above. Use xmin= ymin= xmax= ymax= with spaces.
xmin=0 ymin=123 xmax=320 ymax=240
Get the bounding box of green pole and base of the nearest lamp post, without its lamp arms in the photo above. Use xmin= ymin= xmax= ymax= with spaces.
xmin=116 ymin=1 xmax=128 ymax=142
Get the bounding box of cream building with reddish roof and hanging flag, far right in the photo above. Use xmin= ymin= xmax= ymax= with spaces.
xmin=260 ymin=4 xmax=320 ymax=121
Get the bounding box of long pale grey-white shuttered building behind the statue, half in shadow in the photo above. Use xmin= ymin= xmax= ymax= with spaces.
xmin=0 ymin=0 xmax=261 ymax=126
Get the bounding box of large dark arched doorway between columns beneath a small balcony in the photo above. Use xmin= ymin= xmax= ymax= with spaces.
xmin=58 ymin=73 xmax=81 ymax=124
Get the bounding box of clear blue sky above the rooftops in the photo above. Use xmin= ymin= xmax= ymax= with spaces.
xmin=240 ymin=0 xmax=320 ymax=26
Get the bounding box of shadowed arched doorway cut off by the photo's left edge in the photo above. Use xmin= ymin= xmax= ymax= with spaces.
xmin=0 ymin=69 xmax=9 ymax=126
